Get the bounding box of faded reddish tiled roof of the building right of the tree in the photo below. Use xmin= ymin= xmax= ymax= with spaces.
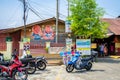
xmin=102 ymin=18 xmax=120 ymax=35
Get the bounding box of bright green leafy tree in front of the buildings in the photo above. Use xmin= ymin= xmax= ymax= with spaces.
xmin=68 ymin=0 xmax=108 ymax=39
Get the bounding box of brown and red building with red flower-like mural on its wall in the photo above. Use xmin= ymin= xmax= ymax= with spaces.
xmin=0 ymin=17 xmax=67 ymax=57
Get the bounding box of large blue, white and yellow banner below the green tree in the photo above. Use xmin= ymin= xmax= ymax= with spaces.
xmin=76 ymin=39 xmax=91 ymax=55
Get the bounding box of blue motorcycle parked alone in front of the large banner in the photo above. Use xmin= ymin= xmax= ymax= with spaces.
xmin=66 ymin=53 xmax=93 ymax=73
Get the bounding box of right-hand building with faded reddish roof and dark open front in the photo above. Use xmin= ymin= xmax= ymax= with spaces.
xmin=102 ymin=18 xmax=120 ymax=55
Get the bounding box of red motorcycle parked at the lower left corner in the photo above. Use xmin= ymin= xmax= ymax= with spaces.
xmin=0 ymin=54 xmax=28 ymax=80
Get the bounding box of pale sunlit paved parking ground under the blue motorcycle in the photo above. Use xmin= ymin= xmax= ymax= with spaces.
xmin=28 ymin=58 xmax=120 ymax=80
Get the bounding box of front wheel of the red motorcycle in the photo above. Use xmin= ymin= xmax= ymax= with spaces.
xmin=12 ymin=70 xmax=28 ymax=80
